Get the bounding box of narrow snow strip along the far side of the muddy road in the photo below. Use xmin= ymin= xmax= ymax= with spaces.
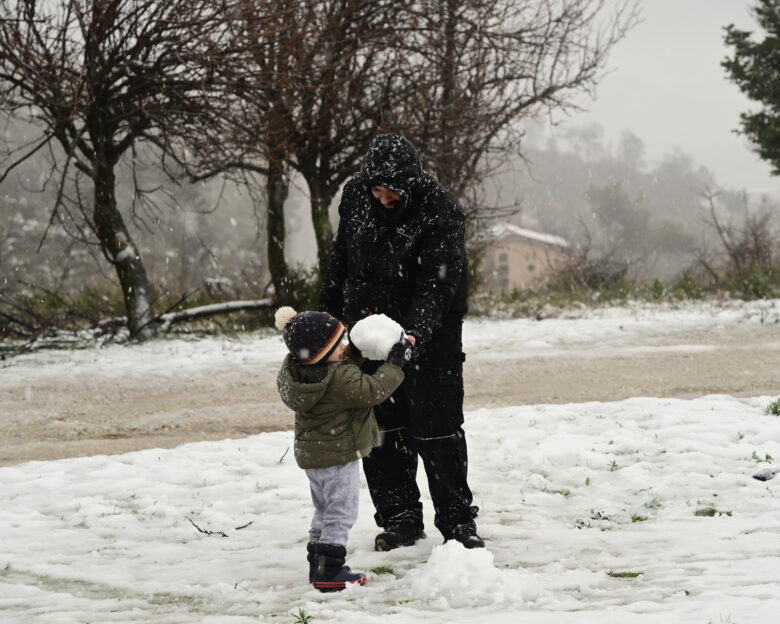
xmin=0 ymin=299 xmax=780 ymax=385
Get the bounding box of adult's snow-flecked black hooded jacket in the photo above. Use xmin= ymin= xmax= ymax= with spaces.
xmin=320 ymin=134 xmax=468 ymax=343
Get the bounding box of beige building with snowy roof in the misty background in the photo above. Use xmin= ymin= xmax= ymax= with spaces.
xmin=482 ymin=223 xmax=571 ymax=292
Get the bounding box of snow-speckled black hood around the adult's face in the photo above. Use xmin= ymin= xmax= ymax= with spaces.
xmin=360 ymin=134 xmax=423 ymax=222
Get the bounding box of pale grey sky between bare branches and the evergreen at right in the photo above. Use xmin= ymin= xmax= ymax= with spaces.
xmin=565 ymin=0 xmax=780 ymax=198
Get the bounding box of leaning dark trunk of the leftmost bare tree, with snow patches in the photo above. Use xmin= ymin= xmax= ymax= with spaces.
xmin=93 ymin=156 xmax=156 ymax=340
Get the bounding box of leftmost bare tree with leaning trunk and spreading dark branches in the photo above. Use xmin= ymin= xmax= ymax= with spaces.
xmin=0 ymin=0 xmax=250 ymax=339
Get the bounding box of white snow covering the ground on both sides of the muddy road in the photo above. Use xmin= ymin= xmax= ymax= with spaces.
xmin=0 ymin=302 xmax=780 ymax=624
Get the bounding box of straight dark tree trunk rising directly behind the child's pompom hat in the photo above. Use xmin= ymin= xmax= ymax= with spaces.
xmin=266 ymin=161 xmax=295 ymax=305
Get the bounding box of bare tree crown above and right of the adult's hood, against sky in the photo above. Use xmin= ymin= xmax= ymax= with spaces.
xmin=395 ymin=0 xmax=637 ymax=212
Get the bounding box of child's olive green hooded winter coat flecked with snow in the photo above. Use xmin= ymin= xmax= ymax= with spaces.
xmin=276 ymin=354 xmax=404 ymax=468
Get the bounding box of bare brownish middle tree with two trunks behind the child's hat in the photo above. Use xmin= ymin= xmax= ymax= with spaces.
xmin=230 ymin=0 xmax=398 ymax=300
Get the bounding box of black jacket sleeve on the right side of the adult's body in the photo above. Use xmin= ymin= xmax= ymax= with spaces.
xmin=403 ymin=202 xmax=466 ymax=341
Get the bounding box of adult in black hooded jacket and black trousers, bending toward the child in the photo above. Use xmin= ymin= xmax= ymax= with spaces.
xmin=320 ymin=134 xmax=484 ymax=550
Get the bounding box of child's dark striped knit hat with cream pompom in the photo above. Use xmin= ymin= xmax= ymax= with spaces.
xmin=274 ymin=306 xmax=346 ymax=365
